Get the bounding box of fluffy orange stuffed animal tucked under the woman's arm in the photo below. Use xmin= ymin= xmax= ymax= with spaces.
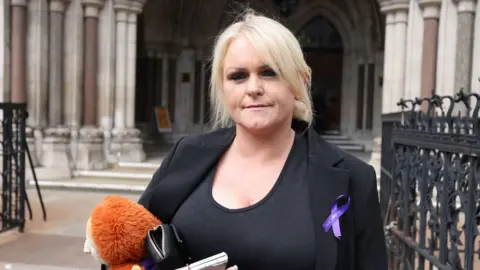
xmin=84 ymin=196 xmax=161 ymax=270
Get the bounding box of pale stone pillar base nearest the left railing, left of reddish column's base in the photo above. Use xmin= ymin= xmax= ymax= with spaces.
xmin=41 ymin=127 xmax=72 ymax=169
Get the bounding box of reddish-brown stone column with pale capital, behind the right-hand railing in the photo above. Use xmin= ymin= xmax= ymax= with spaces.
xmin=419 ymin=0 xmax=442 ymax=110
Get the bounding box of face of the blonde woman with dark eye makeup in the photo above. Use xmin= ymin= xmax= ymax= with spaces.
xmin=223 ymin=37 xmax=295 ymax=132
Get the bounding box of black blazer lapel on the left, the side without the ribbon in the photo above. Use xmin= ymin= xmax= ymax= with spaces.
xmin=148 ymin=129 xmax=235 ymax=223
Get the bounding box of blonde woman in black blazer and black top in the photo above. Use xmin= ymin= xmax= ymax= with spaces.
xmin=140 ymin=9 xmax=387 ymax=270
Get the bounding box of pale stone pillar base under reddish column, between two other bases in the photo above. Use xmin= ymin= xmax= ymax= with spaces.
xmin=75 ymin=127 xmax=108 ymax=170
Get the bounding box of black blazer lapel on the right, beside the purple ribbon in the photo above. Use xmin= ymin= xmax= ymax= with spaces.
xmin=308 ymin=130 xmax=349 ymax=270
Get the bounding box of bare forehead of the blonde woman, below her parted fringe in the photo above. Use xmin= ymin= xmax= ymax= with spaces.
xmin=224 ymin=36 xmax=266 ymax=69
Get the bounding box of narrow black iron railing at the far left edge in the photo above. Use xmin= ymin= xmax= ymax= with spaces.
xmin=0 ymin=103 xmax=46 ymax=232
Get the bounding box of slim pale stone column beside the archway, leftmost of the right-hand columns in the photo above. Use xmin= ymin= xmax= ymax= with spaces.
xmin=382 ymin=2 xmax=395 ymax=114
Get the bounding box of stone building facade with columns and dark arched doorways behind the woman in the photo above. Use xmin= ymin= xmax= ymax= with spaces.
xmin=0 ymin=0 xmax=480 ymax=170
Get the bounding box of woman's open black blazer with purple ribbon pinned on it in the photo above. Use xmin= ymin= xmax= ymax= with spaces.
xmin=139 ymin=128 xmax=387 ymax=270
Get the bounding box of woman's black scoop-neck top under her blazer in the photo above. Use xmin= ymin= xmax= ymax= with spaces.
xmin=172 ymin=135 xmax=315 ymax=270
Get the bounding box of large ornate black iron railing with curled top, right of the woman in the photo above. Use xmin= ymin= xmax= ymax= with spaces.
xmin=380 ymin=91 xmax=480 ymax=270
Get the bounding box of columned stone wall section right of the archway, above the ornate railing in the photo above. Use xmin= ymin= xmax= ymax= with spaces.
xmin=380 ymin=0 xmax=480 ymax=113
